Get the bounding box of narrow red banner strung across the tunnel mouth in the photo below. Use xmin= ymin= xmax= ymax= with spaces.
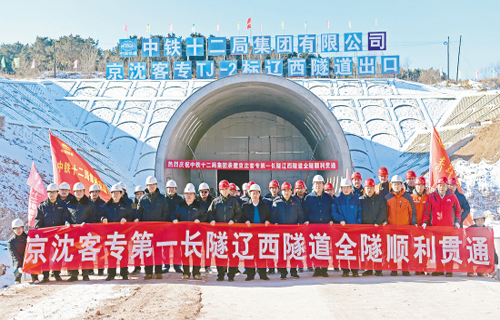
xmin=166 ymin=160 xmax=338 ymax=170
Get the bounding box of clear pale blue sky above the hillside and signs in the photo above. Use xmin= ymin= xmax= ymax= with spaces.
xmin=0 ymin=0 xmax=500 ymax=78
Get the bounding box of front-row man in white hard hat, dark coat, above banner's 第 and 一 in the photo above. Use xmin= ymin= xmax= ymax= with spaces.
xmin=134 ymin=176 xmax=170 ymax=280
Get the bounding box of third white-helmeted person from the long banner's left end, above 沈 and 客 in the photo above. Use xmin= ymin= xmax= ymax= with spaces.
xmin=64 ymin=182 xmax=98 ymax=282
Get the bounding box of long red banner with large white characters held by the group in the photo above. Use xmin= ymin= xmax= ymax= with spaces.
xmin=23 ymin=222 xmax=494 ymax=274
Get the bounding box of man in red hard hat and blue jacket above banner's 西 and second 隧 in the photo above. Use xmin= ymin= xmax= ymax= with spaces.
xmin=271 ymin=181 xmax=305 ymax=280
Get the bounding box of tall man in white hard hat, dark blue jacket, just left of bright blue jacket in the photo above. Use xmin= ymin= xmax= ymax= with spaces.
xmin=302 ymin=175 xmax=333 ymax=277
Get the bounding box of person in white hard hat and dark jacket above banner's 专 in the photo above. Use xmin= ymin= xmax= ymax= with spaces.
xmin=99 ymin=184 xmax=134 ymax=281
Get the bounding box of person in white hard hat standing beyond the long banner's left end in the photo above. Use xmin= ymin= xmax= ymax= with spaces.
xmin=7 ymin=219 xmax=38 ymax=283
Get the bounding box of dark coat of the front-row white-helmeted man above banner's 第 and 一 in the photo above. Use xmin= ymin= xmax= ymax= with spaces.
xmin=136 ymin=188 xmax=170 ymax=221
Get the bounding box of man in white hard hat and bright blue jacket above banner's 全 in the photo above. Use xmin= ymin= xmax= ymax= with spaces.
xmin=332 ymin=179 xmax=362 ymax=277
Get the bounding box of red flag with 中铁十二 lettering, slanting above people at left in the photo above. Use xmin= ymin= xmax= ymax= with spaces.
xmin=49 ymin=132 xmax=111 ymax=201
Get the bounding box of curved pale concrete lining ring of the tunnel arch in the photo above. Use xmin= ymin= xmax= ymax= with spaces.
xmin=155 ymin=74 xmax=353 ymax=191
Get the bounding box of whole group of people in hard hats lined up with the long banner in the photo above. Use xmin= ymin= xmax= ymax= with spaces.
xmin=8 ymin=167 xmax=496 ymax=283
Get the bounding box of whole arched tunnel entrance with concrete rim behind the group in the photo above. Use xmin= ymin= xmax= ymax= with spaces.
xmin=155 ymin=74 xmax=352 ymax=192
